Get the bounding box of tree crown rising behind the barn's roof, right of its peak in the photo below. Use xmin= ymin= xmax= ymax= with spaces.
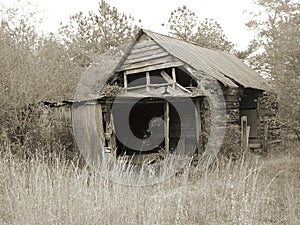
xmin=168 ymin=6 xmax=234 ymax=52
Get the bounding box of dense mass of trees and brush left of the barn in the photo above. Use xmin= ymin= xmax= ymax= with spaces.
xmin=0 ymin=1 xmax=141 ymax=147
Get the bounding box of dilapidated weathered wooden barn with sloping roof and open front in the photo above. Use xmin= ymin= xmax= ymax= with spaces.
xmin=45 ymin=30 xmax=278 ymax=163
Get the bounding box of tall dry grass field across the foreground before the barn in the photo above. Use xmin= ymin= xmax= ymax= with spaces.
xmin=0 ymin=143 xmax=300 ymax=224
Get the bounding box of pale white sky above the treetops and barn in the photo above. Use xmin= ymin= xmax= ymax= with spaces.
xmin=0 ymin=0 xmax=259 ymax=49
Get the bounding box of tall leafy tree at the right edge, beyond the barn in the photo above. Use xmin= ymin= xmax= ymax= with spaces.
xmin=248 ymin=0 xmax=300 ymax=140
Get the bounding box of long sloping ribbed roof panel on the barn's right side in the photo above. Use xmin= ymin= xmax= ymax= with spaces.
xmin=140 ymin=30 xmax=269 ymax=90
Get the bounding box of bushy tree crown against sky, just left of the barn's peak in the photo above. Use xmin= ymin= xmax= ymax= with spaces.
xmin=60 ymin=0 xmax=138 ymax=66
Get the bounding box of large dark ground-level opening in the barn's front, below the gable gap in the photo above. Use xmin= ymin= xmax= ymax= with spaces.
xmin=114 ymin=100 xmax=181 ymax=156
